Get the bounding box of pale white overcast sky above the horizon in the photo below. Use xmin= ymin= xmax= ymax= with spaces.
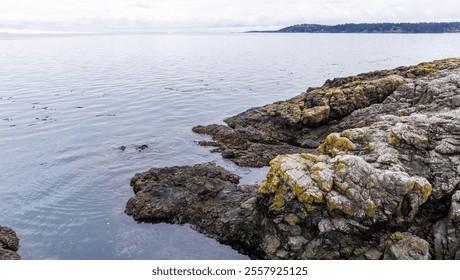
xmin=0 ymin=0 xmax=460 ymax=31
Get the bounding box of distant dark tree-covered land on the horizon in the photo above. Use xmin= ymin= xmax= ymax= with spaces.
xmin=249 ymin=22 xmax=460 ymax=33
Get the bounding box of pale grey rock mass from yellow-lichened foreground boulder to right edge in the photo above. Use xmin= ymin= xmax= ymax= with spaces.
xmin=258 ymin=58 xmax=460 ymax=259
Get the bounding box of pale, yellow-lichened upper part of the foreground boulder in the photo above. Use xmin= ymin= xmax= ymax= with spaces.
xmin=259 ymin=154 xmax=432 ymax=225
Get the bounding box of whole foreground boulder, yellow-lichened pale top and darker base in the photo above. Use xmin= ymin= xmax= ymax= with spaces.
xmin=258 ymin=154 xmax=432 ymax=259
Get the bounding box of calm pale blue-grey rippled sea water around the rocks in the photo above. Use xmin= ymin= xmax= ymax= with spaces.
xmin=0 ymin=34 xmax=460 ymax=259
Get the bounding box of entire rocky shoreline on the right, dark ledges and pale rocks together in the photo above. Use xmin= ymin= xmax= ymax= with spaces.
xmin=126 ymin=58 xmax=460 ymax=259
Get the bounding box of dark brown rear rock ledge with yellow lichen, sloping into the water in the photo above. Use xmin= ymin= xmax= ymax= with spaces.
xmin=193 ymin=59 xmax=459 ymax=167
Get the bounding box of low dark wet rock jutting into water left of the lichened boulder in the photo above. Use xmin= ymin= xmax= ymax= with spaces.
xmin=125 ymin=163 xmax=259 ymax=256
